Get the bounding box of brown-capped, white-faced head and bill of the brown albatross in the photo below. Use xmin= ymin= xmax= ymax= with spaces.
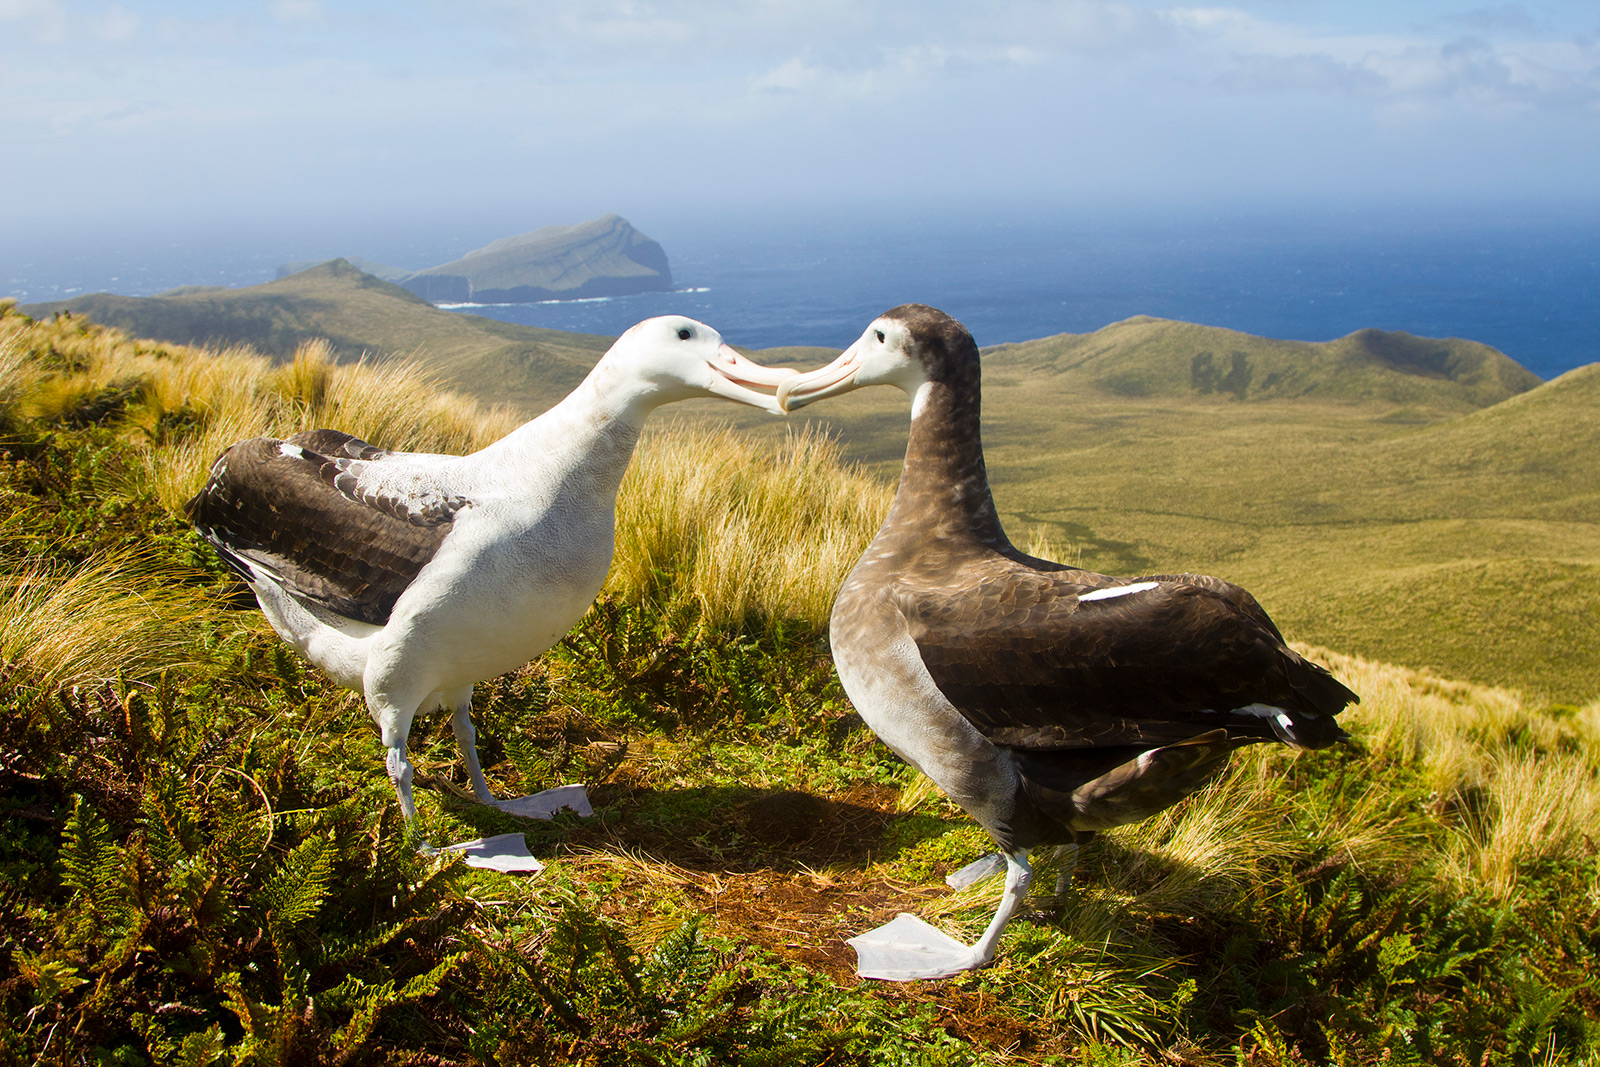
xmin=778 ymin=304 xmax=978 ymax=411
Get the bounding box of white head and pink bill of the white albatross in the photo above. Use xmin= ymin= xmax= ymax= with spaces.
xmin=595 ymin=315 xmax=795 ymax=414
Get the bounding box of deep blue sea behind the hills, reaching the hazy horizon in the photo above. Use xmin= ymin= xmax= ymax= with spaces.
xmin=0 ymin=210 xmax=1600 ymax=378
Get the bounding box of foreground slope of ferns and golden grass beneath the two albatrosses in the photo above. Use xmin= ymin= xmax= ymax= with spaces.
xmin=0 ymin=306 xmax=1600 ymax=1065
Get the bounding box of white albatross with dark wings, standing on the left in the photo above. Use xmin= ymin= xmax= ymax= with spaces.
xmin=186 ymin=315 xmax=794 ymax=844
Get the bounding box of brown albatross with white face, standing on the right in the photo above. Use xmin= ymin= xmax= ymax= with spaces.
xmin=778 ymin=304 xmax=1358 ymax=981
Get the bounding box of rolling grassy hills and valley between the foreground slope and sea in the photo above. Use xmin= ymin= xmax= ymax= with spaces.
xmin=15 ymin=267 xmax=1600 ymax=699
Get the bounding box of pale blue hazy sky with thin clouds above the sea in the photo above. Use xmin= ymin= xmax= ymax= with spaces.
xmin=0 ymin=0 xmax=1600 ymax=251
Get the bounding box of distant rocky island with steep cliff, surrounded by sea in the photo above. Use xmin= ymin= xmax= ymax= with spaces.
xmin=278 ymin=214 xmax=672 ymax=304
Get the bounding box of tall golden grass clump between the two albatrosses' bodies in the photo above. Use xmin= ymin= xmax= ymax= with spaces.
xmin=606 ymin=424 xmax=893 ymax=629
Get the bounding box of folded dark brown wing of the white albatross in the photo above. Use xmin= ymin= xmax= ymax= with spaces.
xmin=184 ymin=430 xmax=466 ymax=625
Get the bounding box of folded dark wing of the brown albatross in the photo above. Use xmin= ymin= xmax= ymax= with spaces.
xmin=899 ymin=563 xmax=1357 ymax=750
